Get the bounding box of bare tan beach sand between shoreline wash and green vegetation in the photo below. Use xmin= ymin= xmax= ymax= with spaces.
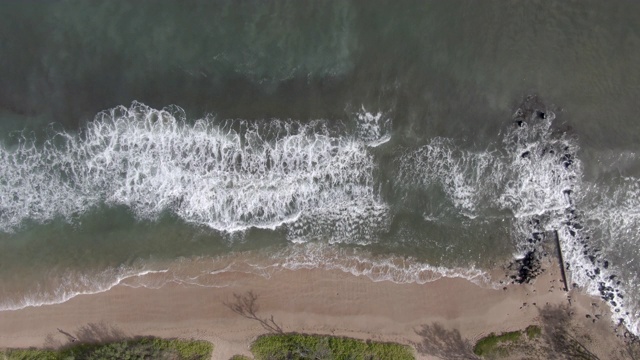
xmin=0 ymin=262 xmax=624 ymax=359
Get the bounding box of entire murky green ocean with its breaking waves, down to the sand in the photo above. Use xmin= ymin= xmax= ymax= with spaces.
xmin=0 ymin=1 xmax=640 ymax=334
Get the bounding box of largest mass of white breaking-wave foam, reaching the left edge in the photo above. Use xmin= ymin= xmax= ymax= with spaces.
xmin=0 ymin=103 xmax=390 ymax=243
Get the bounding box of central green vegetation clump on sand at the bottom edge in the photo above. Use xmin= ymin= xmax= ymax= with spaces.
xmin=251 ymin=334 xmax=415 ymax=360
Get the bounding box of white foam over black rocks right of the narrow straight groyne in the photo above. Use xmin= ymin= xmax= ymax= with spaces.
xmin=564 ymin=177 xmax=640 ymax=335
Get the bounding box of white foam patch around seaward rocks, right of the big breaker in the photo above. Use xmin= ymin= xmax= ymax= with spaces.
xmin=399 ymin=114 xmax=581 ymax=222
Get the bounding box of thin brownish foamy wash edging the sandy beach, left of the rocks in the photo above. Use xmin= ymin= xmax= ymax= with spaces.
xmin=0 ymin=242 xmax=498 ymax=311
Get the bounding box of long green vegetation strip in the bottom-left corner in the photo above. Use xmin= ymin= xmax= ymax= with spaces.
xmin=0 ymin=337 xmax=213 ymax=360
